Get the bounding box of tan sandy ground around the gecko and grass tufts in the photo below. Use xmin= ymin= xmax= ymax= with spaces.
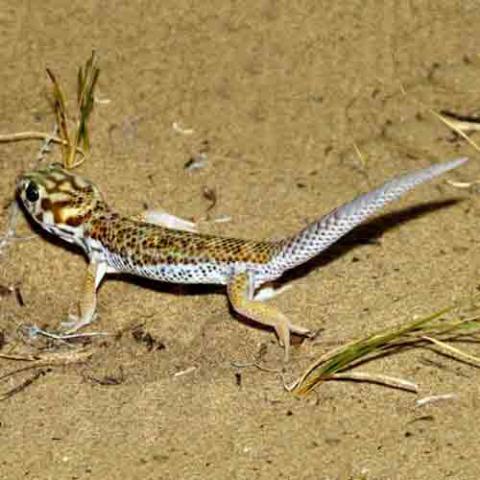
xmin=0 ymin=0 xmax=480 ymax=480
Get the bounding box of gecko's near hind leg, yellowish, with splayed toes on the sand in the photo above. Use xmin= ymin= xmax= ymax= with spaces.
xmin=227 ymin=272 xmax=310 ymax=362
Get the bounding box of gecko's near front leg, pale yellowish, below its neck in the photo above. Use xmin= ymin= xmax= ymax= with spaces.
xmin=61 ymin=259 xmax=107 ymax=333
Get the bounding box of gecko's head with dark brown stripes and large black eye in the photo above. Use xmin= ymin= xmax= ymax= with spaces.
xmin=17 ymin=163 xmax=105 ymax=243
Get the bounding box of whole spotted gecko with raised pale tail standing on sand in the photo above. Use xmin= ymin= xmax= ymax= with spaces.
xmin=16 ymin=158 xmax=467 ymax=362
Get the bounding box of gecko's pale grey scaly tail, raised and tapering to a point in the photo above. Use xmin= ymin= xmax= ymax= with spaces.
xmin=273 ymin=158 xmax=468 ymax=271
